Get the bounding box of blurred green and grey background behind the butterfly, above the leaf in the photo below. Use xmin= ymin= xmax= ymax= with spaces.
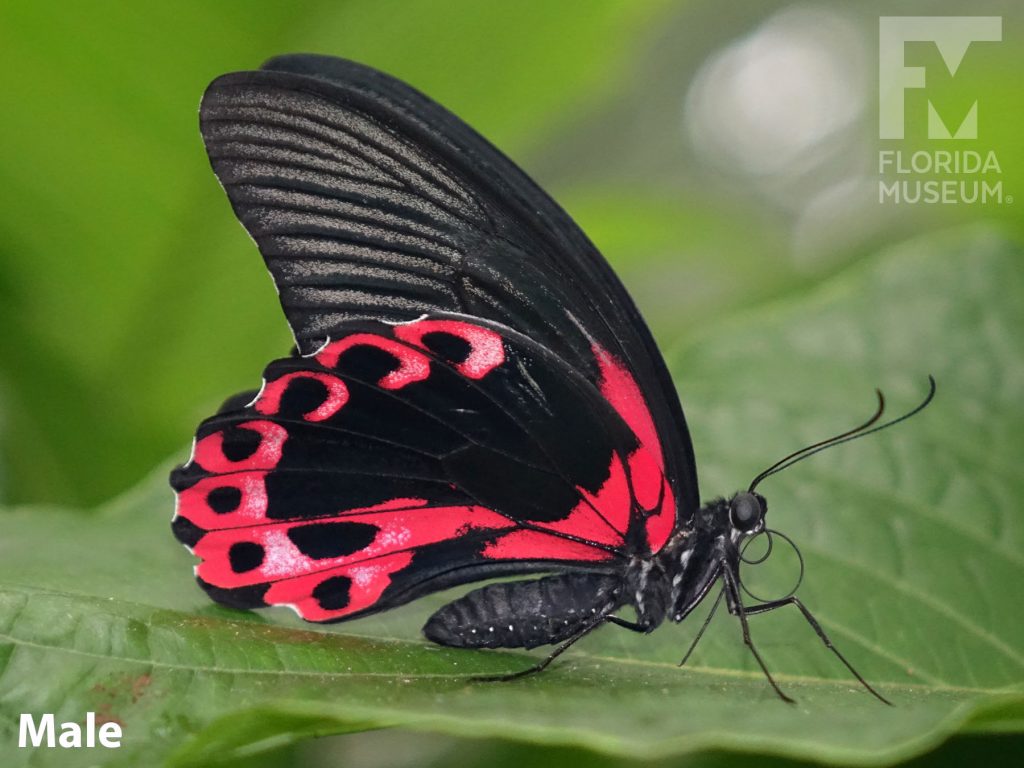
xmin=0 ymin=0 xmax=1024 ymax=766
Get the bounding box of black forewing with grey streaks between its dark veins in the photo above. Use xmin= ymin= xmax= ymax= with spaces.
xmin=201 ymin=55 xmax=698 ymax=523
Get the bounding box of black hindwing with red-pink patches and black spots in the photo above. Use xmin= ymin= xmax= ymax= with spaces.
xmin=172 ymin=316 xmax=675 ymax=622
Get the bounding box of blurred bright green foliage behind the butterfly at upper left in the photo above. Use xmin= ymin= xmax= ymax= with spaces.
xmin=0 ymin=0 xmax=664 ymax=504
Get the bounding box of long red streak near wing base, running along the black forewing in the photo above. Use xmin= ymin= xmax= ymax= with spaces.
xmin=592 ymin=344 xmax=676 ymax=552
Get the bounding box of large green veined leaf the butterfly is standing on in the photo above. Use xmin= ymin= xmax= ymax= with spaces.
xmin=0 ymin=229 xmax=1024 ymax=766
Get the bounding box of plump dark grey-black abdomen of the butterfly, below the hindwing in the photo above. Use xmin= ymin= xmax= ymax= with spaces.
xmin=423 ymin=573 xmax=622 ymax=648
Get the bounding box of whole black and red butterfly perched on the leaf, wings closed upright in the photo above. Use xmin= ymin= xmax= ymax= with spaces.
xmin=170 ymin=55 xmax=934 ymax=700
